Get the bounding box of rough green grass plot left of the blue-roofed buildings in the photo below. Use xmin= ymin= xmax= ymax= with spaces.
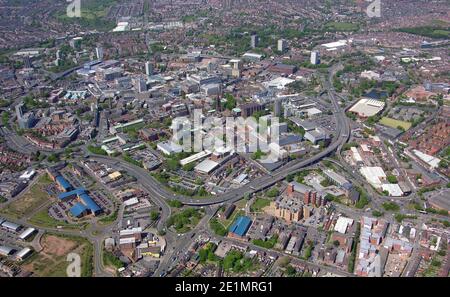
xmin=2 ymin=174 xmax=52 ymax=218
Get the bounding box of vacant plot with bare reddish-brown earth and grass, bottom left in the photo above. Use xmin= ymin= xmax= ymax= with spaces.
xmin=23 ymin=234 xmax=93 ymax=277
